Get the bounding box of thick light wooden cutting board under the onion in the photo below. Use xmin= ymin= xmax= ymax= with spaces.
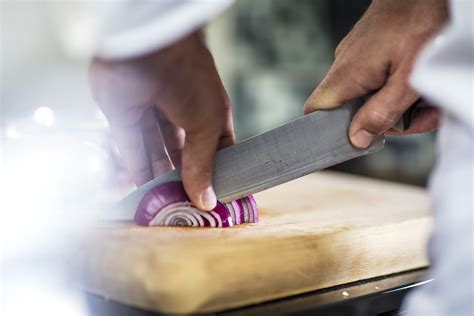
xmin=72 ymin=172 xmax=431 ymax=313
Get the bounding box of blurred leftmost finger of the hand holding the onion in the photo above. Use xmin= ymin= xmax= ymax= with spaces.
xmin=109 ymin=110 xmax=153 ymax=186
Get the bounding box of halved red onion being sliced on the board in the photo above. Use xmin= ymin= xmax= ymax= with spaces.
xmin=135 ymin=182 xmax=258 ymax=227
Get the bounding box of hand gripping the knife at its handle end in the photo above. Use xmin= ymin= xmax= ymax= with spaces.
xmin=304 ymin=0 xmax=447 ymax=148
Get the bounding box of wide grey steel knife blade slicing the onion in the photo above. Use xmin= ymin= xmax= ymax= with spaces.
xmin=107 ymin=99 xmax=384 ymax=219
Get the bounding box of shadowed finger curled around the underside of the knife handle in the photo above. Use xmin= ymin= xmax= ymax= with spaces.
xmin=387 ymin=107 xmax=441 ymax=135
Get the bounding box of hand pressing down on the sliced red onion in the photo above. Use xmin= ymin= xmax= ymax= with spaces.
xmin=90 ymin=34 xmax=234 ymax=210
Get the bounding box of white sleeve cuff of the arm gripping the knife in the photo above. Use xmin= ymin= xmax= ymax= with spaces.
xmin=411 ymin=0 xmax=474 ymax=127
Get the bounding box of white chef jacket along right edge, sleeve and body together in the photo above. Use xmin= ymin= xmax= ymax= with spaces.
xmin=405 ymin=0 xmax=474 ymax=316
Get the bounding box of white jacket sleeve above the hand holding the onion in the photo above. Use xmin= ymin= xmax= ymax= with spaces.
xmin=94 ymin=0 xmax=232 ymax=59
